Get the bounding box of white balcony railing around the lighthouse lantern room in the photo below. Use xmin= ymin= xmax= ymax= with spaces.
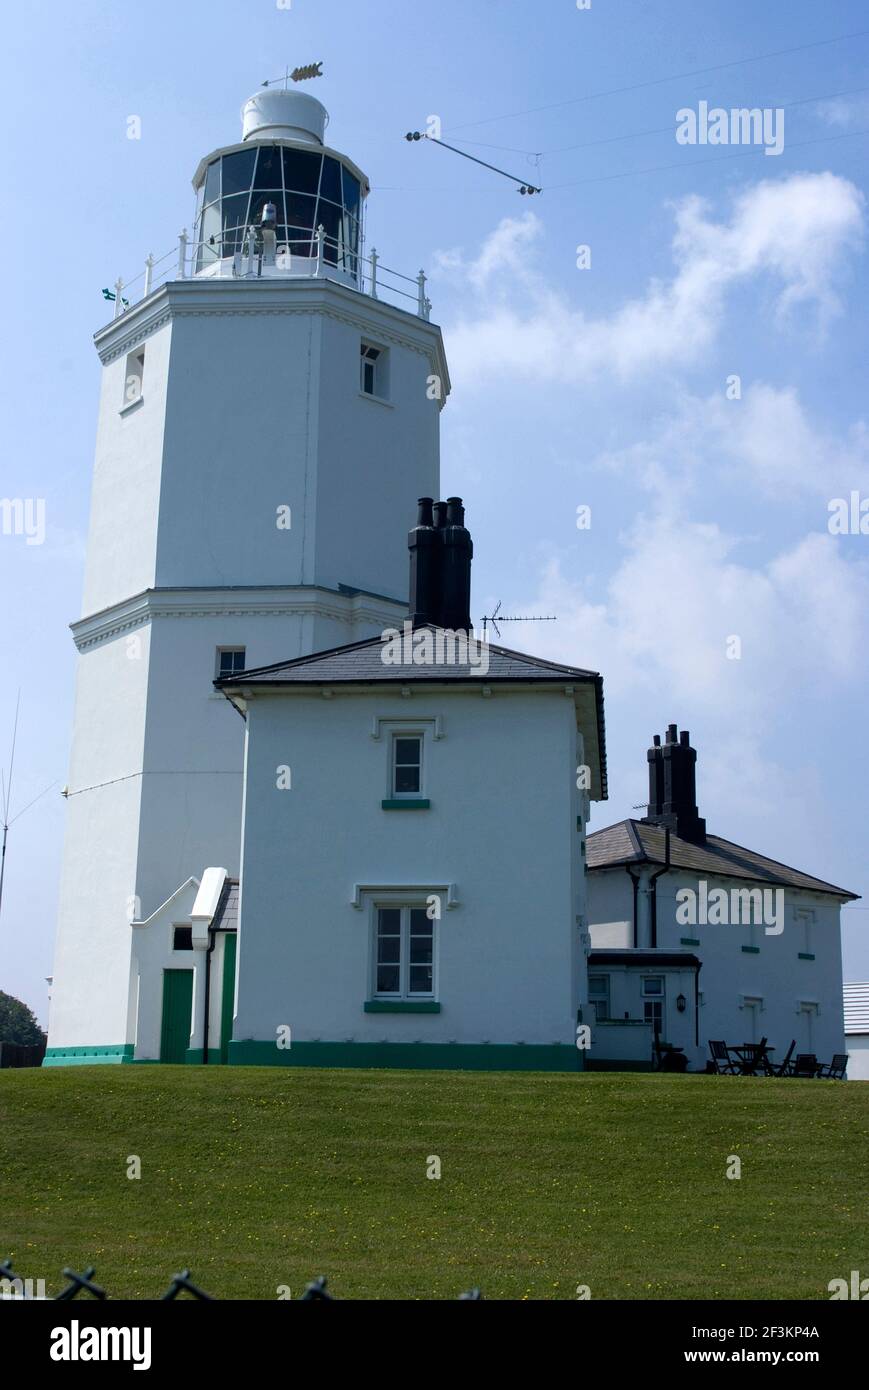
xmin=103 ymin=227 xmax=431 ymax=320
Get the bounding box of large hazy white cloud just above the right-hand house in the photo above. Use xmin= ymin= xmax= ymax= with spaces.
xmin=511 ymin=517 xmax=869 ymax=731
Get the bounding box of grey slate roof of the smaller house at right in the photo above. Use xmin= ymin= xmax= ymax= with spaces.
xmin=585 ymin=820 xmax=859 ymax=898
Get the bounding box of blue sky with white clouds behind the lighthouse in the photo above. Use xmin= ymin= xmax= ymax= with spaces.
xmin=0 ymin=0 xmax=869 ymax=1023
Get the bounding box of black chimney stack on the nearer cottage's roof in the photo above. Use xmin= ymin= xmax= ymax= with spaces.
xmin=407 ymin=498 xmax=474 ymax=632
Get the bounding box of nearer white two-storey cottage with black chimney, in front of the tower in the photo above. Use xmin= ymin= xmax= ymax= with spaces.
xmin=212 ymin=499 xmax=605 ymax=1070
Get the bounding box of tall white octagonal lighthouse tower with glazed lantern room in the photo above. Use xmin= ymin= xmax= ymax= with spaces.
xmin=47 ymin=81 xmax=449 ymax=1065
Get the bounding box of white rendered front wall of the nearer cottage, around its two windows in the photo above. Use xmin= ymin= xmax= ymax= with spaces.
xmin=234 ymin=687 xmax=584 ymax=1045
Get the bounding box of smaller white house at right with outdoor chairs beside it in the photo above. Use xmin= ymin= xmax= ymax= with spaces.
xmin=587 ymin=724 xmax=855 ymax=1069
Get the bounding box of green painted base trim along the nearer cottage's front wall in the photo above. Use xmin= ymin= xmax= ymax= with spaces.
xmin=229 ymin=1038 xmax=583 ymax=1072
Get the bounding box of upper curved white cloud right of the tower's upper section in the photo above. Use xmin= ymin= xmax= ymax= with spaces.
xmin=439 ymin=172 xmax=863 ymax=384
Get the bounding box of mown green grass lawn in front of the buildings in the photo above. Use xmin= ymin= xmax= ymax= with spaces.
xmin=0 ymin=1066 xmax=869 ymax=1298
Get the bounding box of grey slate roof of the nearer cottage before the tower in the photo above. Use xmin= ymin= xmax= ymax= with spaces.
xmin=214 ymin=627 xmax=606 ymax=799
